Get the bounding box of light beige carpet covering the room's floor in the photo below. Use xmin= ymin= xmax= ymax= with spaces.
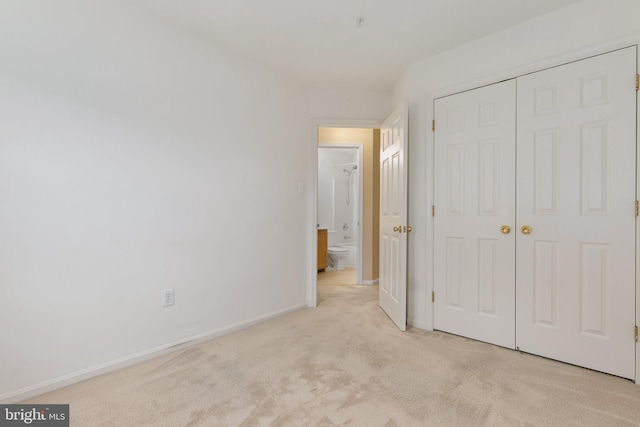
xmin=23 ymin=286 xmax=640 ymax=426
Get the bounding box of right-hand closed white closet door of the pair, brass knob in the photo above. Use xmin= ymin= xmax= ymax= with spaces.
xmin=514 ymin=48 xmax=636 ymax=378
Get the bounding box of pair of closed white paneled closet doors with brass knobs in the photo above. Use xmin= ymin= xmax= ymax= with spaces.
xmin=434 ymin=47 xmax=637 ymax=379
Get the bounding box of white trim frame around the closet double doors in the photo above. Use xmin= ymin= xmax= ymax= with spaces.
xmin=422 ymin=36 xmax=640 ymax=386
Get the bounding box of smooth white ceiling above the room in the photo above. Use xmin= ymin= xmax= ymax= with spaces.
xmin=128 ymin=0 xmax=579 ymax=90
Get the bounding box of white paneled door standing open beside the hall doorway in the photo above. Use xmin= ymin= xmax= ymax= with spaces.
xmin=379 ymin=105 xmax=410 ymax=331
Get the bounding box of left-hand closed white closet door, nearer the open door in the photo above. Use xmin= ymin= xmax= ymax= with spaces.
xmin=434 ymin=80 xmax=516 ymax=348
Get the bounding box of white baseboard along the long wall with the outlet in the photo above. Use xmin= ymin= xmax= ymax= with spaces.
xmin=0 ymin=303 xmax=307 ymax=404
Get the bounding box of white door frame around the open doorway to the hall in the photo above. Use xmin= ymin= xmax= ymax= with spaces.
xmin=306 ymin=119 xmax=382 ymax=307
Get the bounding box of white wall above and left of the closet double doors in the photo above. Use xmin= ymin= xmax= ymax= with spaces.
xmin=392 ymin=0 xmax=640 ymax=328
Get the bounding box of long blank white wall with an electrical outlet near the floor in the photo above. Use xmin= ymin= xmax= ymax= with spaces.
xmin=0 ymin=0 xmax=309 ymax=402
